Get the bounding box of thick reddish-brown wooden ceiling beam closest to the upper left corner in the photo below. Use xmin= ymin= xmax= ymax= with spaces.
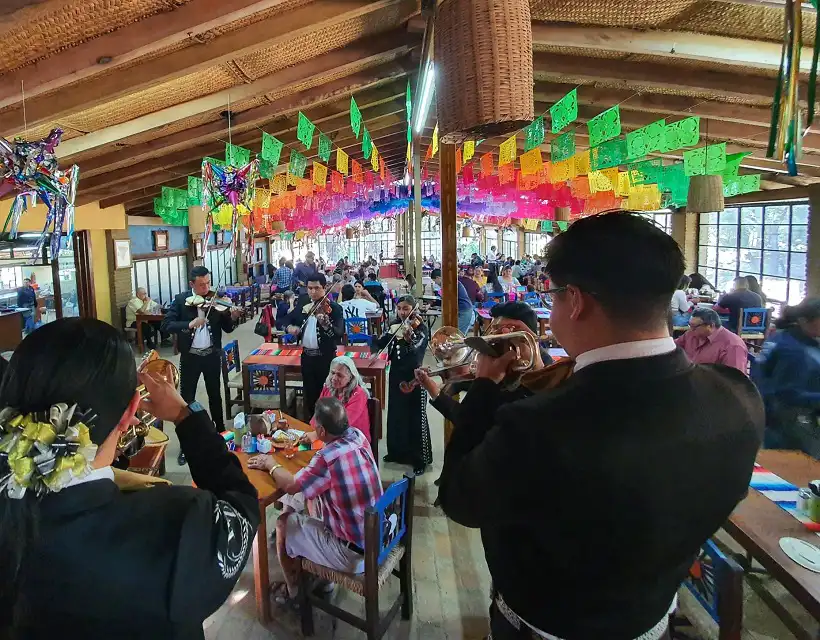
xmin=0 ymin=0 xmax=294 ymax=108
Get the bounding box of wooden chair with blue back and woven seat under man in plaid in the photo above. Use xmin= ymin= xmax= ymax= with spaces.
xmin=299 ymin=476 xmax=415 ymax=640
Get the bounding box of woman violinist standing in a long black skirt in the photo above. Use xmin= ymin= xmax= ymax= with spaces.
xmin=376 ymin=296 xmax=433 ymax=476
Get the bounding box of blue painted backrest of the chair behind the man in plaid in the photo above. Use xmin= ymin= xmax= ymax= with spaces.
xmin=364 ymin=475 xmax=416 ymax=571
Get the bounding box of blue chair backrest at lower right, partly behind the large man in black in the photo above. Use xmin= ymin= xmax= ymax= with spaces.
xmin=683 ymin=540 xmax=743 ymax=640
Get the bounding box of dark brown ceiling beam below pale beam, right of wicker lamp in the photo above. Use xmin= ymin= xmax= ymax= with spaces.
xmin=533 ymin=52 xmax=775 ymax=100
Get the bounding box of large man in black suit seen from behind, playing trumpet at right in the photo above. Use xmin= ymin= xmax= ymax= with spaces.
xmin=439 ymin=212 xmax=764 ymax=640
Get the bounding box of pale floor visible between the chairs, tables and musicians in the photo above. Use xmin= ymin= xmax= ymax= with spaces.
xmin=141 ymin=296 xmax=817 ymax=640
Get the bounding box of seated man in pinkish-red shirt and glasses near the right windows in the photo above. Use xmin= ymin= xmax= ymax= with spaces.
xmin=675 ymin=309 xmax=749 ymax=373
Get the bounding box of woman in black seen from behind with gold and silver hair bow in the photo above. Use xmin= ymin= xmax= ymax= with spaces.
xmin=0 ymin=318 xmax=259 ymax=640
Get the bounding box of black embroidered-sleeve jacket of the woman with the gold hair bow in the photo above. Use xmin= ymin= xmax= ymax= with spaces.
xmin=16 ymin=411 xmax=259 ymax=640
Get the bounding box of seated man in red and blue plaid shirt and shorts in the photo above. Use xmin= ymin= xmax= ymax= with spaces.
xmin=248 ymin=398 xmax=382 ymax=598
